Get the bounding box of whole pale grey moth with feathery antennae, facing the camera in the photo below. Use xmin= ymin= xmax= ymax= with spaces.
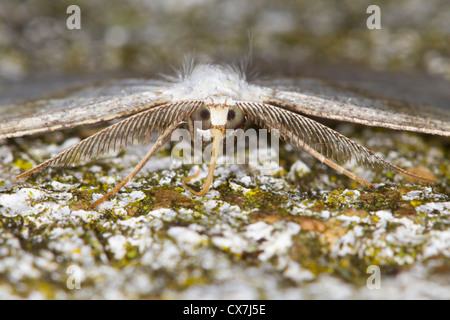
xmin=0 ymin=63 xmax=450 ymax=208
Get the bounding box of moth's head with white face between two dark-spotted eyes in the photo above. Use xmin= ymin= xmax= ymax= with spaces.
xmin=191 ymin=105 xmax=245 ymax=130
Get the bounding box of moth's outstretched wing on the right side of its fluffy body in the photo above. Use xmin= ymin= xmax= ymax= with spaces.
xmin=258 ymin=73 xmax=450 ymax=136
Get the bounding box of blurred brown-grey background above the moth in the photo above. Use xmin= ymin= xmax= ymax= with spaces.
xmin=0 ymin=0 xmax=450 ymax=81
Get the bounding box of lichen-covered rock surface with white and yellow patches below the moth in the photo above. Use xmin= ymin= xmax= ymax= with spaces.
xmin=0 ymin=127 xmax=450 ymax=299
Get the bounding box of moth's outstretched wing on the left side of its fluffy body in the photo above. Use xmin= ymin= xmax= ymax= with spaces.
xmin=0 ymin=80 xmax=170 ymax=139
